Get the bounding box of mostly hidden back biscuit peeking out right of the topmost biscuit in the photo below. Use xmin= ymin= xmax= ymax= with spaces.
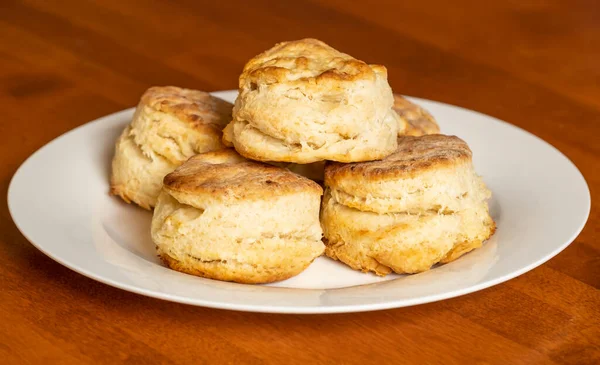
xmin=392 ymin=94 xmax=440 ymax=136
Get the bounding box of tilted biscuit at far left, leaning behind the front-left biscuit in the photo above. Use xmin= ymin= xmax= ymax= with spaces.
xmin=110 ymin=86 xmax=233 ymax=209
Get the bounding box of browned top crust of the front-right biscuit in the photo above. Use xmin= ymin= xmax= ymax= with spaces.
xmin=325 ymin=134 xmax=471 ymax=187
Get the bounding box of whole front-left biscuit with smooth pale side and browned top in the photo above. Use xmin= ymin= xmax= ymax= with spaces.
xmin=151 ymin=149 xmax=324 ymax=283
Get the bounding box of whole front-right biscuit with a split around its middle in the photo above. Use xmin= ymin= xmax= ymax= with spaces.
xmin=321 ymin=135 xmax=495 ymax=275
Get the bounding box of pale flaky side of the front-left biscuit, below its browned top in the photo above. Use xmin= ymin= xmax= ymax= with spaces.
xmin=151 ymin=191 xmax=324 ymax=283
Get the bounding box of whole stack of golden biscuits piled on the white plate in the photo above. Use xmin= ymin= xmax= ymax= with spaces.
xmin=111 ymin=39 xmax=495 ymax=283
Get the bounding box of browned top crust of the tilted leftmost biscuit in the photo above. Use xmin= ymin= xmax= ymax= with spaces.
xmin=140 ymin=86 xmax=233 ymax=131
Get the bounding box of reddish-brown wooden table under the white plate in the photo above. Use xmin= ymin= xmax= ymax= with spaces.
xmin=0 ymin=0 xmax=600 ymax=364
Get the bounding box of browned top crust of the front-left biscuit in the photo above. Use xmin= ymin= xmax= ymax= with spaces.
xmin=163 ymin=149 xmax=323 ymax=207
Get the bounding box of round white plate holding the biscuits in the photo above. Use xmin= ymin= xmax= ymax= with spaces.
xmin=8 ymin=91 xmax=590 ymax=313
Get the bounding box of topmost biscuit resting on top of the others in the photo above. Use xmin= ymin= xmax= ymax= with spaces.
xmin=223 ymin=39 xmax=400 ymax=164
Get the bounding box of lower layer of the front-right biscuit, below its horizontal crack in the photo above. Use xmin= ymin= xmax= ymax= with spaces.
xmin=321 ymin=191 xmax=495 ymax=275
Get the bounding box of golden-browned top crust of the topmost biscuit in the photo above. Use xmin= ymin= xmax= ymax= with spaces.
xmin=239 ymin=38 xmax=387 ymax=88
